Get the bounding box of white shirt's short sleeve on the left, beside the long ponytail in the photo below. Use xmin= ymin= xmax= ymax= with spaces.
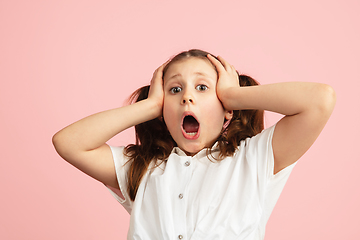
xmin=106 ymin=146 xmax=132 ymax=214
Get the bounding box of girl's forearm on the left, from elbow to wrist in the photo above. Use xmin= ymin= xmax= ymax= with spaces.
xmin=53 ymin=100 xmax=159 ymax=152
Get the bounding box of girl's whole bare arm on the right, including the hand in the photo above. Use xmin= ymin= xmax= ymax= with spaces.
xmin=209 ymin=57 xmax=336 ymax=174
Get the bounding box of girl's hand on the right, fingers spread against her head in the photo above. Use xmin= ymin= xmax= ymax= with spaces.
xmin=207 ymin=54 xmax=240 ymax=110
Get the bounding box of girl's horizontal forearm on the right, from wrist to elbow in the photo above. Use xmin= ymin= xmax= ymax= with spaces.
xmin=222 ymin=82 xmax=335 ymax=115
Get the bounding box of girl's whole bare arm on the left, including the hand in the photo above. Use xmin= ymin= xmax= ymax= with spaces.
xmin=52 ymin=63 xmax=166 ymax=188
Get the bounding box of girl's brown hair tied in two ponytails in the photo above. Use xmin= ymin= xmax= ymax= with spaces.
xmin=125 ymin=49 xmax=264 ymax=201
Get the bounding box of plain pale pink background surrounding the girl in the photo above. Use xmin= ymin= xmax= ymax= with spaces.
xmin=0 ymin=0 xmax=360 ymax=240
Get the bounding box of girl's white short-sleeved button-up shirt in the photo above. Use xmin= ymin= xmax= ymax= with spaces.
xmin=109 ymin=125 xmax=295 ymax=240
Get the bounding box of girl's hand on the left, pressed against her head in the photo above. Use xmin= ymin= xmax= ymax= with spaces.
xmin=148 ymin=60 xmax=170 ymax=117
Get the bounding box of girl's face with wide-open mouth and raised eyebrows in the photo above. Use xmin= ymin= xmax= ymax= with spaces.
xmin=163 ymin=57 xmax=232 ymax=155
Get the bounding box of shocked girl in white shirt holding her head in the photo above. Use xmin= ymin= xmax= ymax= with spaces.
xmin=53 ymin=50 xmax=335 ymax=240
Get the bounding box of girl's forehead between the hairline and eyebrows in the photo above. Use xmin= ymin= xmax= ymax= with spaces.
xmin=164 ymin=57 xmax=217 ymax=81
